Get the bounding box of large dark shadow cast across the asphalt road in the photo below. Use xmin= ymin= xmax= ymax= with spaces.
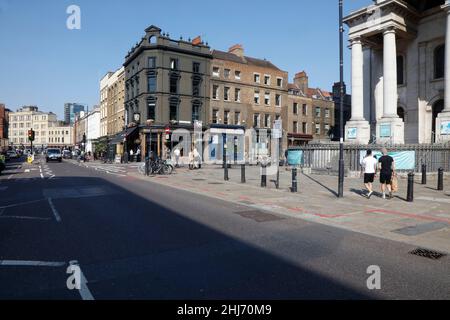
xmin=0 ymin=177 xmax=371 ymax=299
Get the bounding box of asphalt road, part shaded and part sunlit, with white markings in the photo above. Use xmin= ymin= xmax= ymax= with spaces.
xmin=0 ymin=156 xmax=450 ymax=300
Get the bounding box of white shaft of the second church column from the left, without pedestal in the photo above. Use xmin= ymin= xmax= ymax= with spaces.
xmin=383 ymin=28 xmax=398 ymax=118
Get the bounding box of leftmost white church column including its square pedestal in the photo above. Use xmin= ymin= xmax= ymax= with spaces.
xmin=345 ymin=37 xmax=370 ymax=144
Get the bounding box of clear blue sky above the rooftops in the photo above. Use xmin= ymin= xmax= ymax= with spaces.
xmin=0 ymin=0 xmax=372 ymax=118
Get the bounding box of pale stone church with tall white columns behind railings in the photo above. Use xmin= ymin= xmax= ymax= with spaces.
xmin=344 ymin=0 xmax=450 ymax=144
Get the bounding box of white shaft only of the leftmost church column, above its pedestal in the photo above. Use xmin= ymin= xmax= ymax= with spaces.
xmin=351 ymin=38 xmax=364 ymax=121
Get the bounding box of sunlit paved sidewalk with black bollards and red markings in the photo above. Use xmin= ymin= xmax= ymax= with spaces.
xmin=128 ymin=166 xmax=450 ymax=253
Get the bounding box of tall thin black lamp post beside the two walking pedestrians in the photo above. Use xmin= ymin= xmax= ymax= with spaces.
xmin=338 ymin=0 xmax=344 ymax=198
